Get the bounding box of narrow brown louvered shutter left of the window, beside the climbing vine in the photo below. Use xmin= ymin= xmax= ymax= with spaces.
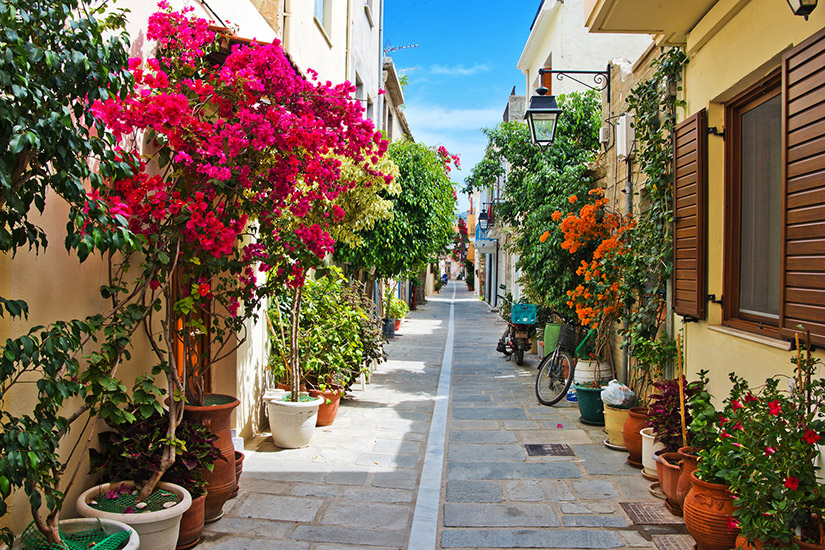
xmin=673 ymin=109 xmax=708 ymax=319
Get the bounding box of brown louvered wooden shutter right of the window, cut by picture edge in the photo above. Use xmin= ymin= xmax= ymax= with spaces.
xmin=779 ymin=30 xmax=825 ymax=345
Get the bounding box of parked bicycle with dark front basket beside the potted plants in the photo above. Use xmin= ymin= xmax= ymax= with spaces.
xmin=536 ymin=324 xmax=592 ymax=406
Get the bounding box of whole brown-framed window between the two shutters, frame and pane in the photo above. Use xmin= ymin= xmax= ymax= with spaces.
xmin=724 ymin=73 xmax=783 ymax=336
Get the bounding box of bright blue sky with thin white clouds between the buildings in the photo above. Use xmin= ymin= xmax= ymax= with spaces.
xmin=384 ymin=0 xmax=541 ymax=211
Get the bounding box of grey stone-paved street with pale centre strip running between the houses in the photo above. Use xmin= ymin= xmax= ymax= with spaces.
xmin=200 ymin=282 xmax=692 ymax=550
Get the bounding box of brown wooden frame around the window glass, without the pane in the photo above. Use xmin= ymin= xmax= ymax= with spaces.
xmin=722 ymin=70 xmax=785 ymax=338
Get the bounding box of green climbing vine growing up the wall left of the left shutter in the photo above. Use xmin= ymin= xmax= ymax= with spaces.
xmin=623 ymin=48 xmax=687 ymax=370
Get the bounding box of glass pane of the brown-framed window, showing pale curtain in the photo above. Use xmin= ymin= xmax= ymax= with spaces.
xmin=739 ymin=96 xmax=782 ymax=319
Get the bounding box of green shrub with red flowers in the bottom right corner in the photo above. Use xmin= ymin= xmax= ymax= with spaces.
xmin=698 ymin=336 xmax=825 ymax=548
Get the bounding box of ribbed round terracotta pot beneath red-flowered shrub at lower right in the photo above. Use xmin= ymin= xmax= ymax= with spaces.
xmin=683 ymin=472 xmax=739 ymax=550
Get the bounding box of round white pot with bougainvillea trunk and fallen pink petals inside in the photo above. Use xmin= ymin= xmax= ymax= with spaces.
xmin=77 ymin=481 xmax=192 ymax=550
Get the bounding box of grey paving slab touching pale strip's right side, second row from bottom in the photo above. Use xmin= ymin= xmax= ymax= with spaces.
xmin=444 ymin=502 xmax=560 ymax=527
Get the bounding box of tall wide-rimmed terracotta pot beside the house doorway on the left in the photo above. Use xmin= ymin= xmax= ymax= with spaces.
xmin=184 ymin=393 xmax=241 ymax=523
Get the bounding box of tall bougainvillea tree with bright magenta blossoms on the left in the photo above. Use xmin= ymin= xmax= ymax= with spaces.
xmin=94 ymin=2 xmax=393 ymax=495
